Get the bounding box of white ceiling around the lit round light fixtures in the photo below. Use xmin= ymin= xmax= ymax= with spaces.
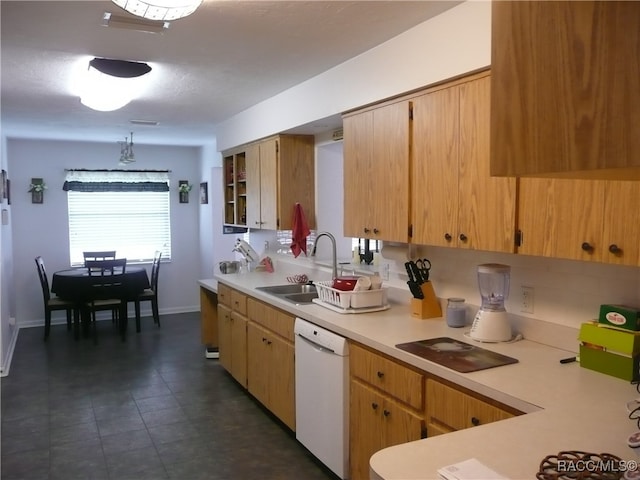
xmin=0 ymin=0 xmax=460 ymax=146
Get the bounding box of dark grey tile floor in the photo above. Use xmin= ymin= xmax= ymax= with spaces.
xmin=0 ymin=313 xmax=337 ymax=480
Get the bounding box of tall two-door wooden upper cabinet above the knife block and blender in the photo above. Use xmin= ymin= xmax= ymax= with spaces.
xmin=412 ymin=72 xmax=516 ymax=252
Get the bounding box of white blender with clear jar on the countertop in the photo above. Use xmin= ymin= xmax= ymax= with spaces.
xmin=469 ymin=263 xmax=512 ymax=342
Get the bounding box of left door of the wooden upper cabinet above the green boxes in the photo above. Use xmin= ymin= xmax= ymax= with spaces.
xmin=518 ymin=178 xmax=605 ymax=261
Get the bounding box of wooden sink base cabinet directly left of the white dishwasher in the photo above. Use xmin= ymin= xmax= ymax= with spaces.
xmin=247 ymin=299 xmax=296 ymax=430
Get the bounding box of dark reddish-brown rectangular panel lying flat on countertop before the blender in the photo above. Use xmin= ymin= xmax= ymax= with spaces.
xmin=396 ymin=337 xmax=518 ymax=373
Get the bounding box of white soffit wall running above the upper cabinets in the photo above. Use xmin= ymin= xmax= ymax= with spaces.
xmin=216 ymin=1 xmax=491 ymax=150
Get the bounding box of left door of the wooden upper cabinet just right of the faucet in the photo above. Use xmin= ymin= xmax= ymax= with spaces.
xmin=342 ymin=111 xmax=373 ymax=238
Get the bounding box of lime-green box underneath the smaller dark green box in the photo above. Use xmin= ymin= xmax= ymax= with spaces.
xmin=578 ymin=321 xmax=640 ymax=381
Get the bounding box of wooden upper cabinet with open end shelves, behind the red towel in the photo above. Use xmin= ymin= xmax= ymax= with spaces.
xmin=225 ymin=135 xmax=316 ymax=230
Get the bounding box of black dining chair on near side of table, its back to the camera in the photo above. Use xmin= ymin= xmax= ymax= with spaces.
xmin=85 ymin=258 xmax=127 ymax=343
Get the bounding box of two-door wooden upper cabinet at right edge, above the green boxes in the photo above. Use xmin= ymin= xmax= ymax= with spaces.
xmin=518 ymin=178 xmax=640 ymax=266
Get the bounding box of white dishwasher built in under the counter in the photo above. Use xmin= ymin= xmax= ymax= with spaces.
xmin=294 ymin=318 xmax=349 ymax=479
